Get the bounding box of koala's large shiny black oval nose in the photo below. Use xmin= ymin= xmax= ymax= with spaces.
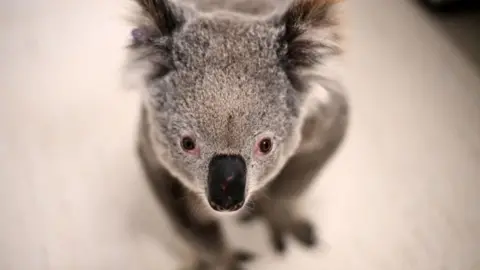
xmin=207 ymin=155 xmax=247 ymax=211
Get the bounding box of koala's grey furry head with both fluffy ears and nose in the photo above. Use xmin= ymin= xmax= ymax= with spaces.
xmin=130 ymin=0 xmax=338 ymax=212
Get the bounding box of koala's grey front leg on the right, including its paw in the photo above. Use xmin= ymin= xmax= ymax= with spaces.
xmin=241 ymin=105 xmax=346 ymax=253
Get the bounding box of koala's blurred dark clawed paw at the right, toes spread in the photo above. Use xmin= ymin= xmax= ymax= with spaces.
xmin=268 ymin=220 xmax=318 ymax=255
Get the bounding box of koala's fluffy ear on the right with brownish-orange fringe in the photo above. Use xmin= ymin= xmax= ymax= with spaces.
xmin=277 ymin=0 xmax=342 ymax=86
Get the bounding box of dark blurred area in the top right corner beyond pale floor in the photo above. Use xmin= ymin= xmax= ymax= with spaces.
xmin=412 ymin=0 xmax=480 ymax=75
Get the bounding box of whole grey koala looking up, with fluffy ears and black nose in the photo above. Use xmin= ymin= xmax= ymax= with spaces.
xmin=128 ymin=0 xmax=349 ymax=270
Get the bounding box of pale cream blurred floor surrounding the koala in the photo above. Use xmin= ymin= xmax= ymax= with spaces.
xmin=0 ymin=0 xmax=480 ymax=270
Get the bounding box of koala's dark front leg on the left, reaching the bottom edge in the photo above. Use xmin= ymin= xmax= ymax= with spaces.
xmin=137 ymin=108 xmax=253 ymax=270
